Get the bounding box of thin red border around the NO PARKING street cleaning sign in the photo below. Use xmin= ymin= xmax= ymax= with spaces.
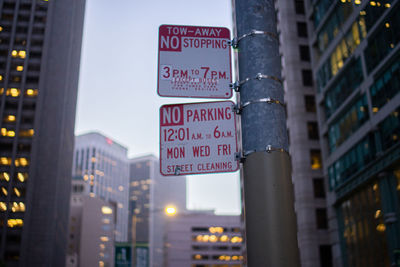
xmin=158 ymin=100 xmax=239 ymax=176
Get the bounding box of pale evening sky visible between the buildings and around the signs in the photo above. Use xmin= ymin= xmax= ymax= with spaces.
xmin=75 ymin=0 xmax=240 ymax=214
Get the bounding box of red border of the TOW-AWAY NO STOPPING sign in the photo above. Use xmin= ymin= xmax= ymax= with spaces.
xmin=157 ymin=24 xmax=233 ymax=99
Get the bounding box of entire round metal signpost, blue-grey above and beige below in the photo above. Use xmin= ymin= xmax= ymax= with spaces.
xmin=233 ymin=0 xmax=300 ymax=267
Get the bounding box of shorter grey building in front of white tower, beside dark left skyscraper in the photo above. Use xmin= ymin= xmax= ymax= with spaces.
xmin=66 ymin=176 xmax=116 ymax=267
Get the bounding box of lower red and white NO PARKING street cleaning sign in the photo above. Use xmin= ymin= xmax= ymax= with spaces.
xmin=160 ymin=101 xmax=239 ymax=176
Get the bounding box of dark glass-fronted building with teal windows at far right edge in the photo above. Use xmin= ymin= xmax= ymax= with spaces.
xmin=306 ymin=0 xmax=400 ymax=267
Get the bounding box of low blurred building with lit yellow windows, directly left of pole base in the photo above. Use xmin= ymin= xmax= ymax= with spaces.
xmin=163 ymin=211 xmax=244 ymax=267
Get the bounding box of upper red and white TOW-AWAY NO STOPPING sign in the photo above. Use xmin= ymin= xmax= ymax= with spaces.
xmin=157 ymin=25 xmax=232 ymax=99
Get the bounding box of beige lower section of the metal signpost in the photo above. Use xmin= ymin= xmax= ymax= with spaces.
xmin=243 ymin=151 xmax=300 ymax=267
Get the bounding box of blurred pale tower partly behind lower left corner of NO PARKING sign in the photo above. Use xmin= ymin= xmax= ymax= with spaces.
xmin=129 ymin=155 xmax=186 ymax=267
